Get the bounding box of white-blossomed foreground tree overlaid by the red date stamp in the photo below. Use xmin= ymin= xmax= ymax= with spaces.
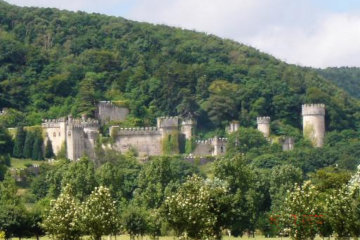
xmin=279 ymin=181 xmax=324 ymax=240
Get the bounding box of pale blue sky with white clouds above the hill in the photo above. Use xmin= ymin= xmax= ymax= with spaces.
xmin=6 ymin=0 xmax=360 ymax=68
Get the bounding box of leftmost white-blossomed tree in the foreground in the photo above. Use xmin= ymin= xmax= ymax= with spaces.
xmin=42 ymin=185 xmax=81 ymax=240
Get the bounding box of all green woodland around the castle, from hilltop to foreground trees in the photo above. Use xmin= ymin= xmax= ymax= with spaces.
xmin=0 ymin=0 xmax=360 ymax=240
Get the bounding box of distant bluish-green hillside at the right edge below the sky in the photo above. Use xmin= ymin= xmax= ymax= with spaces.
xmin=317 ymin=67 xmax=360 ymax=98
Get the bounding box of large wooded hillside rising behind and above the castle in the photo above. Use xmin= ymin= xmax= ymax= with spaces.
xmin=0 ymin=1 xmax=360 ymax=130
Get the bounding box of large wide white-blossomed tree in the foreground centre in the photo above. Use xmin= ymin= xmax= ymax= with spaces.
xmin=163 ymin=175 xmax=230 ymax=239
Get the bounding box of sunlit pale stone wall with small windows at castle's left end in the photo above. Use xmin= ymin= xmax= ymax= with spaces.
xmin=41 ymin=118 xmax=66 ymax=155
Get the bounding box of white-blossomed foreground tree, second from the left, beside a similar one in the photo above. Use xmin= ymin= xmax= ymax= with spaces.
xmin=81 ymin=186 xmax=119 ymax=240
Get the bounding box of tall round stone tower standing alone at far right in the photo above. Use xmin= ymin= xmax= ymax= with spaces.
xmin=302 ymin=104 xmax=325 ymax=147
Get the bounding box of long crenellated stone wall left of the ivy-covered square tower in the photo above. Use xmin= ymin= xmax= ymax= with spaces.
xmin=110 ymin=126 xmax=162 ymax=156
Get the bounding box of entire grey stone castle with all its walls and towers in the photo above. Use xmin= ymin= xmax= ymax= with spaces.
xmin=42 ymin=101 xmax=325 ymax=160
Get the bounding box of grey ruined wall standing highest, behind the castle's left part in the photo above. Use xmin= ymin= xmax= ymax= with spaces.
xmin=96 ymin=101 xmax=129 ymax=124
